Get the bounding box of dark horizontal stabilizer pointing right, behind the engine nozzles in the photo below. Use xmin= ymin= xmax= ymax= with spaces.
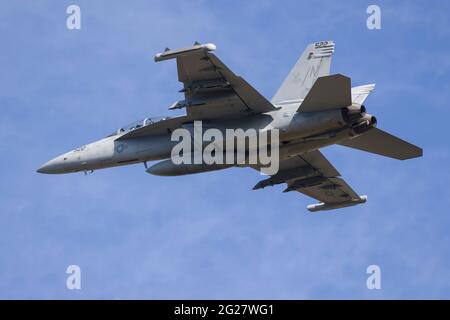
xmin=339 ymin=128 xmax=422 ymax=160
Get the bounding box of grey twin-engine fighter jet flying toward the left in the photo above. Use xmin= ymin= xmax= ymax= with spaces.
xmin=37 ymin=41 xmax=422 ymax=212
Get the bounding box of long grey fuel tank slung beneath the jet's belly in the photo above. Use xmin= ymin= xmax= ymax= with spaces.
xmin=146 ymin=159 xmax=233 ymax=176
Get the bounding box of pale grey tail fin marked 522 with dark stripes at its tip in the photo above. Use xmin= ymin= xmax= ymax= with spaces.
xmin=272 ymin=41 xmax=334 ymax=104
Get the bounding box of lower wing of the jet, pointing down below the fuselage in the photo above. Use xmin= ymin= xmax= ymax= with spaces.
xmin=253 ymin=150 xmax=367 ymax=212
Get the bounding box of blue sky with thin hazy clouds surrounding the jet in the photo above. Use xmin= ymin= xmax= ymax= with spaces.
xmin=0 ymin=1 xmax=450 ymax=299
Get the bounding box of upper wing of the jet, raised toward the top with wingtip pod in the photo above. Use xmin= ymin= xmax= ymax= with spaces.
xmin=155 ymin=44 xmax=277 ymax=120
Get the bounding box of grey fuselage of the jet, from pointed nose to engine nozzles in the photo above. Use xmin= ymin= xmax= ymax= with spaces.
xmin=38 ymin=103 xmax=375 ymax=174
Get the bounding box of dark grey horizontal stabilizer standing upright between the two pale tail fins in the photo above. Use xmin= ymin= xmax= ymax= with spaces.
xmin=297 ymin=74 xmax=352 ymax=112
